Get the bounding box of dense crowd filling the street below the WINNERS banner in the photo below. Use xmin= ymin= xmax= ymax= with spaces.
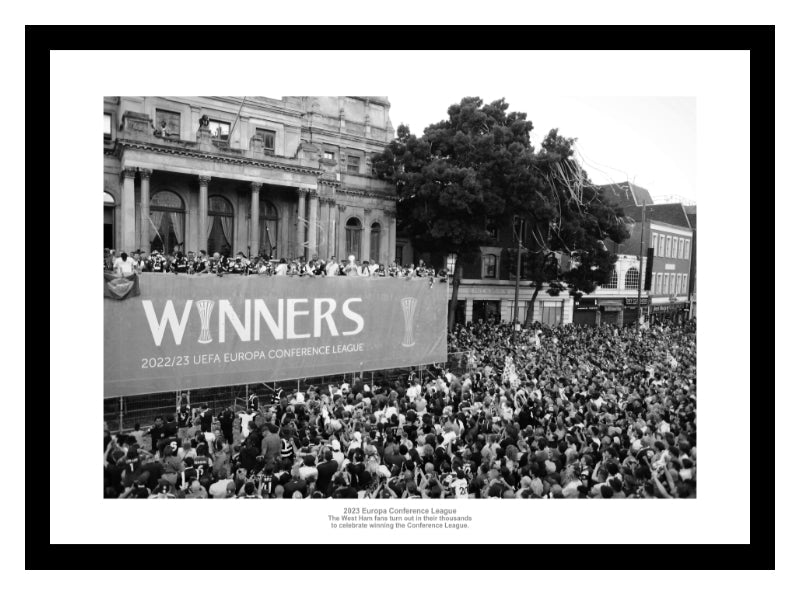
xmin=104 ymin=321 xmax=697 ymax=499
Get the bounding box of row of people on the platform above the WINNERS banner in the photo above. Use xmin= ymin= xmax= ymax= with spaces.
xmin=103 ymin=248 xmax=447 ymax=279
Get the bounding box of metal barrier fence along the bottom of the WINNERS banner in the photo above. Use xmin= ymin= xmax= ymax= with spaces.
xmin=103 ymin=351 xmax=469 ymax=432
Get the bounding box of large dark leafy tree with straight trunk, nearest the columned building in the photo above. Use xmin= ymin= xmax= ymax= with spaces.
xmin=373 ymin=97 xmax=533 ymax=329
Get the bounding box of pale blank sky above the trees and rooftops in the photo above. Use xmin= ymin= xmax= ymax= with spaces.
xmin=389 ymin=94 xmax=697 ymax=204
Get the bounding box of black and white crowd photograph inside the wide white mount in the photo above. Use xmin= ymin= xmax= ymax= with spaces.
xmin=97 ymin=89 xmax=702 ymax=502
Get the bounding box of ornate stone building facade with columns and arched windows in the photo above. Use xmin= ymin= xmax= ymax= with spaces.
xmin=103 ymin=96 xmax=396 ymax=263
